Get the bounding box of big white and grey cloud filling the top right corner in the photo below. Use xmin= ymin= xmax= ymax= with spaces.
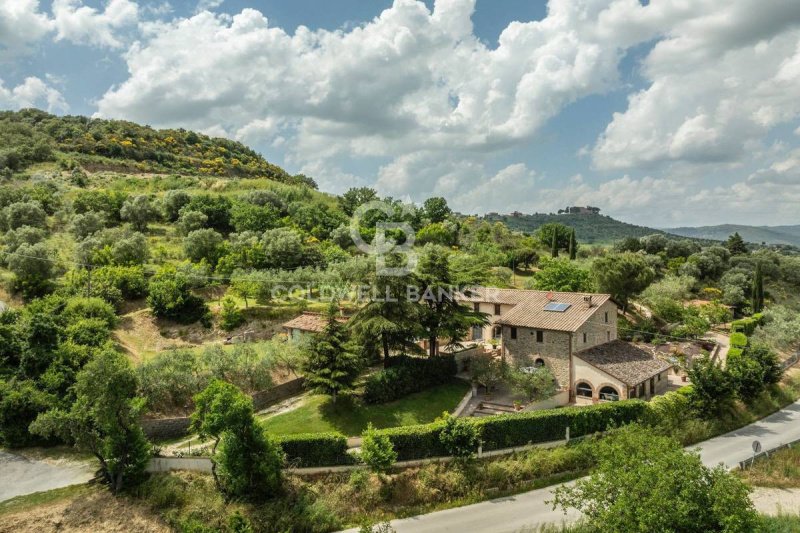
xmin=593 ymin=0 xmax=800 ymax=169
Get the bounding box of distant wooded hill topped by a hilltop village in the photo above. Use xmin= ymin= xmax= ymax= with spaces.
xmin=483 ymin=213 xmax=676 ymax=244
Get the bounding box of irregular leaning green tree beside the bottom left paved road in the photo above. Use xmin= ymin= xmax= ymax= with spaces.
xmin=30 ymin=349 xmax=150 ymax=493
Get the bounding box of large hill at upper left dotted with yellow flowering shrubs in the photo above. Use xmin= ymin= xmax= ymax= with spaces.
xmin=0 ymin=109 xmax=314 ymax=186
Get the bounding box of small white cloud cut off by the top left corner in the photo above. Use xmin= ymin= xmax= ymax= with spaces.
xmin=0 ymin=0 xmax=52 ymax=60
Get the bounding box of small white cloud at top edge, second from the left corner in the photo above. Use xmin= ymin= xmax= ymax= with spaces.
xmin=52 ymin=0 xmax=139 ymax=48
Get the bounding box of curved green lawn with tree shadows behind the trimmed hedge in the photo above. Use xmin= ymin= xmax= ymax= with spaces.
xmin=263 ymin=379 xmax=469 ymax=436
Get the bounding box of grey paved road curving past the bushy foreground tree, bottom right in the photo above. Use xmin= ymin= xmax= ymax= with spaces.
xmin=352 ymin=401 xmax=800 ymax=533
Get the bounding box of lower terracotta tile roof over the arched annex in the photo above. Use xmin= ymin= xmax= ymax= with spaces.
xmin=574 ymin=340 xmax=672 ymax=387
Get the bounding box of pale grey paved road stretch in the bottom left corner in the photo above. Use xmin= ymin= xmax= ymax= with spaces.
xmin=0 ymin=452 xmax=94 ymax=501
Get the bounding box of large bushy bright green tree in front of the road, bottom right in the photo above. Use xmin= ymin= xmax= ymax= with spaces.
xmin=552 ymin=426 xmax=758 ymax=533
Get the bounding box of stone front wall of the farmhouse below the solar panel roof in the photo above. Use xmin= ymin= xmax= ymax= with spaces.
xmin=503 ymin=326 xmax=572 ymax=389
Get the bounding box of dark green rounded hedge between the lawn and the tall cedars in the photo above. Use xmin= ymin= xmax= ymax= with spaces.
xmin=363 ymin=355 xmax=458 ymax=403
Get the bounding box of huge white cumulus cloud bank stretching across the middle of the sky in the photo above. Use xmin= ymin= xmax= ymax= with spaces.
xmin=98 ymin=0 xmax=650 ymax=174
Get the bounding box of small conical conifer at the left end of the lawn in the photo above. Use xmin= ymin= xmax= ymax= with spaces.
xmin=303 ymin=302 xmax=362 ymax=403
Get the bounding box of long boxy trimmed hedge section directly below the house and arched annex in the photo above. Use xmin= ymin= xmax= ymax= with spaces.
xmin=475 ymin=400 xmax=647 ymax=450
